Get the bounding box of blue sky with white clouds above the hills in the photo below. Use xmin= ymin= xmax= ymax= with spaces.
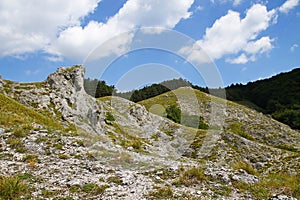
xmin=0 ymin=0 xmax=300 ymax=91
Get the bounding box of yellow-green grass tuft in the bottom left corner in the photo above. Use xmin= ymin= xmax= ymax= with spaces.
xmin=0 ymin=176 xmax=30 ymax=200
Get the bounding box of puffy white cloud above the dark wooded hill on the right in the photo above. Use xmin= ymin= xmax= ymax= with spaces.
xmin=179 ymin=4 xmax=276 ymax=63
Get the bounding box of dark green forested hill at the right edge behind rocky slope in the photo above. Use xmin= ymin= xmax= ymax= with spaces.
xmin=226 ymin=68 xmax=300 ymax=129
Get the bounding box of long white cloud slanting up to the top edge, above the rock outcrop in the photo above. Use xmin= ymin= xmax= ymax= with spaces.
xmin=48 ymin=0 xmax=194 ymax=61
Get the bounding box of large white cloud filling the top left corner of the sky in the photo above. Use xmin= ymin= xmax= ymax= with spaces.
xmin=0 ymin=0 xmax=100 ymax=57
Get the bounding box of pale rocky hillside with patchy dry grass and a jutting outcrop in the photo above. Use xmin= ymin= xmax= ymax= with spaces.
xmin=0 ymin=66 xmax=300 ymax=199
